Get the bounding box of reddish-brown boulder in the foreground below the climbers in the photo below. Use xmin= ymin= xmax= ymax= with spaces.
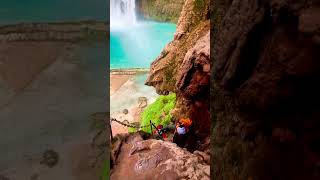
xmin=111 ymin=134 xmax=210 ymax=180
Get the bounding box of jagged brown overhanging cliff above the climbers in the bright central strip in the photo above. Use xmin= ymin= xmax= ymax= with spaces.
xmin=146 ymin=0 xmax=211 ymax=139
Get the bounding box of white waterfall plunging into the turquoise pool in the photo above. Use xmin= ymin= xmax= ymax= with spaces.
xmin=110 ymin=0 xmax=136 ymax=27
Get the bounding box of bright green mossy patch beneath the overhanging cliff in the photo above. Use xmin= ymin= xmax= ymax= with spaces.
xmin=141 ymin=93 xmax=176 ymax=133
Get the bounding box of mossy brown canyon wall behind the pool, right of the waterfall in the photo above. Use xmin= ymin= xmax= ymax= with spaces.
xmin=136 ymin=0 xmax=185 ymax=23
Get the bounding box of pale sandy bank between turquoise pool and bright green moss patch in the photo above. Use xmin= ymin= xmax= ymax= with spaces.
xmin=110 ymin=69 xmax=158 ymax=135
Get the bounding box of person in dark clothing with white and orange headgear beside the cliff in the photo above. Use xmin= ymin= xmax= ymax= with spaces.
xmin=172 ymin=118 xmax=192 ymax=148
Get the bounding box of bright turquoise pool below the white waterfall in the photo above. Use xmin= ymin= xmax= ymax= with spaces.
xmin=110 ymin=22 xmax=176 ymax=69
